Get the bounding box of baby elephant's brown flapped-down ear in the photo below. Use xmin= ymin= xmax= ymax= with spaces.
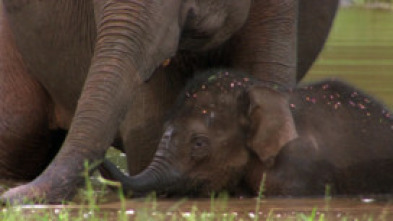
xmin=248 ymin=86 xmax=298 ymax=166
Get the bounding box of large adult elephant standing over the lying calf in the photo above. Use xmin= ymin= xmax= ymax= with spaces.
xmin=0 ymin=0 xmax=337 ymax=202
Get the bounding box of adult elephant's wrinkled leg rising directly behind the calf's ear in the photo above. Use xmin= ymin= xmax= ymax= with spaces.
xmin=231 ymin=0 xmax=298 ymax=88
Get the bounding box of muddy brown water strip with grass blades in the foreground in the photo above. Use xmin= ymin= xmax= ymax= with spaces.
xmin=7 ymin=198 xmax=393 ymax=220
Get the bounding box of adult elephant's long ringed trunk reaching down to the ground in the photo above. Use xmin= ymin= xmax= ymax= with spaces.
xmin=35 ymin=0 xmax=180 ymax=195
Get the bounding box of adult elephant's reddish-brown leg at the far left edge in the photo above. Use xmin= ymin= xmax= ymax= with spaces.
xmin=0 ymin=15 xmax=53 ymax=180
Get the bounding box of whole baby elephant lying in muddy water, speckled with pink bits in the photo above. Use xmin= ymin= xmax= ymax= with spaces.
xmin=105 ymin=70 xmax=393 ymax=196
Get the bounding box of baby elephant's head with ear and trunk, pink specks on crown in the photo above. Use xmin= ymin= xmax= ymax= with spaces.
xmin=119 ymin=71 xmax=297 ymax=195
